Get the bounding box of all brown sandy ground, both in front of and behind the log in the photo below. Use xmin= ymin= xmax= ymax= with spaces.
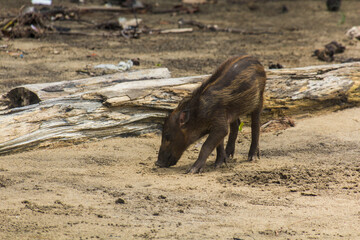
xmin=0 ymin=0 xmax=360 ymax=240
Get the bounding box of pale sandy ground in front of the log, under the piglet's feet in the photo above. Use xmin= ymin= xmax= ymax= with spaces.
xmin=0 ymin=109 xmax=360 ymax=239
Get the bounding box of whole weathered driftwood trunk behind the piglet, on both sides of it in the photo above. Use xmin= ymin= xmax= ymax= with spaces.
xmin=0 ymin=63 xmax=360 ymax=154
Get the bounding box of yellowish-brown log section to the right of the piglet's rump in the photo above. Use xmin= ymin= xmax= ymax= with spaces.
xmin=264 ymin=62 xmax=360 ymax=117
